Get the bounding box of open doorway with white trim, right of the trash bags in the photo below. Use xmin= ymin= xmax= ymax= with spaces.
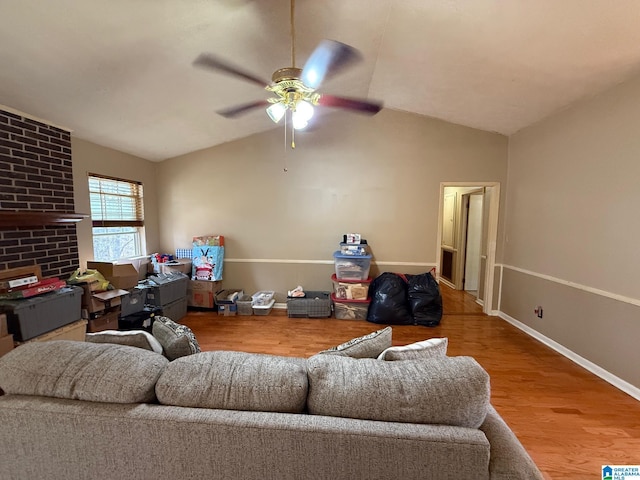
xmin=436 ymin=182 xmax=500 ymax=314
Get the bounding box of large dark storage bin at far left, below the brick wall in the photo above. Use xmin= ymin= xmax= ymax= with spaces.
xmin=0 ymin=286 xmax=84 ymax=342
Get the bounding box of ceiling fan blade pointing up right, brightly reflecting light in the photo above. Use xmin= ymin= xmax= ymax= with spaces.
xmin=300 ymin=40 xmax=362 ymax=89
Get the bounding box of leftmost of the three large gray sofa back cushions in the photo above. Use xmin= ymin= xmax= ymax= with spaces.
xmin=0 ymin=340 xmax=169 ymax=403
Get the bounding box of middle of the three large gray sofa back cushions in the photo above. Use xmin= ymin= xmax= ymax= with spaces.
xmin=156 ymin=351 xmax=308 ymax=413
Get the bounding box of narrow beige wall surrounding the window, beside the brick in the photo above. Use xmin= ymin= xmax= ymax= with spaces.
xmin=71 ymin=137 xmax=159 ymax=268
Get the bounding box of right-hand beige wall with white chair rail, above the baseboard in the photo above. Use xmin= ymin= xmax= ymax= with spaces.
xmin=501 ymin=72 xmax=640 ymax=388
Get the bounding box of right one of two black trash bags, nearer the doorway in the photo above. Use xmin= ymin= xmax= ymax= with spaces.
xmin=406 ymin=272 xmax=442 ymax=327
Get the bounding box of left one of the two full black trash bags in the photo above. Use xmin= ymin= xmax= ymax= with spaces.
xmin=367 ymin=272 xmax=414 ymax=325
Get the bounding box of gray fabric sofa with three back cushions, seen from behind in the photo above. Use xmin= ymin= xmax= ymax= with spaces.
xmin=0 ymin=330 xmax=542 ymax=480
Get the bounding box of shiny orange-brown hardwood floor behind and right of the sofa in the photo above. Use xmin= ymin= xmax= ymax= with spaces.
xmin=181 ymin=285 xmax=640 ymax=480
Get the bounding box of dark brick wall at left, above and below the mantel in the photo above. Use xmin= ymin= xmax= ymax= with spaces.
xmin=0 ymin=109 xmax=79 ymax=278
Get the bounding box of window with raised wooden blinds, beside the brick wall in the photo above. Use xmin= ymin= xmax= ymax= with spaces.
xmin=89 ymin=173 xmax=144 ymax=261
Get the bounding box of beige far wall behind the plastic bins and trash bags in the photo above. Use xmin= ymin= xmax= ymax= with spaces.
xmin=158 ymin=110 xmax=507 ymax=292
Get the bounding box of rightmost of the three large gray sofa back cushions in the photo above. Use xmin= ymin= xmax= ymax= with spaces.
xmin=307 ymin=355 xmax=490 ymax=428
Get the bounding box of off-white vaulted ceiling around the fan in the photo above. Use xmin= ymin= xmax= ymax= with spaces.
xmin=0 ymin=0 xmax=640 ymax=161
